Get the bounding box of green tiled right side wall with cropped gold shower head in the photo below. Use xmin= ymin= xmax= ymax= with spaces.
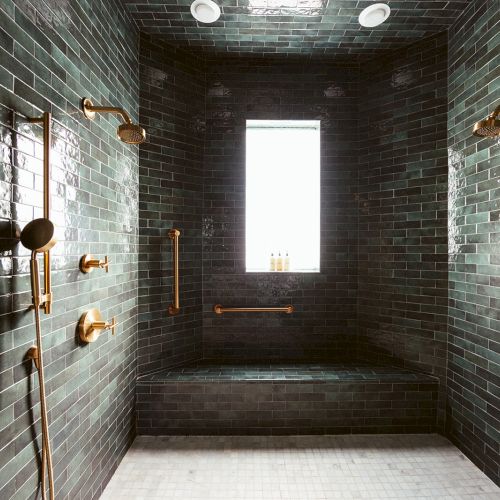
xmin=448 ymin=0 xmax=500 ymax=484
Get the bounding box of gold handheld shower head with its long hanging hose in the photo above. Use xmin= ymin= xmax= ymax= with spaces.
xmin=21 ymin=218 xmax=56 ymax=500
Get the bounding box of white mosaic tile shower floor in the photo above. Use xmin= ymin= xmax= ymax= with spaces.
xmin=101 ymin=435 xmax=500 ymax=500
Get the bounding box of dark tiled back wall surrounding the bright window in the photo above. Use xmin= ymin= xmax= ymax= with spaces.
xmin=203 ymin=58 xmax=358 ymax=362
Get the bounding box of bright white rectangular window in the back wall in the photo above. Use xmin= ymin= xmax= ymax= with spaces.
xmin=246 ymin=120 xmax=320 ymax=272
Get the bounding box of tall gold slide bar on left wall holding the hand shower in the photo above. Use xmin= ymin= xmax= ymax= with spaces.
xmin=28 ymin=111 xmax=52 ymax=314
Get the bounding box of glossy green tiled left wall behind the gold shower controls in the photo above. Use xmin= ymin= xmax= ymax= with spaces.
xmin=0 ymin=0 xmax=139 ymax=500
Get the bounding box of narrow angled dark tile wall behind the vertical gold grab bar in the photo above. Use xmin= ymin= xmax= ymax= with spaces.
xmin=138 ymin=34 xmax=205 ymax=373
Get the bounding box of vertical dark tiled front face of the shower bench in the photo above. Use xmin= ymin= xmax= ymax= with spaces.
xmin=137 ymin=377 xmax=438 ymax=435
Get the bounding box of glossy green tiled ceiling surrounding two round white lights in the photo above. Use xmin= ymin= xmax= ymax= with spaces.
xmin=123 ymin=0 xmax=472 ymax=57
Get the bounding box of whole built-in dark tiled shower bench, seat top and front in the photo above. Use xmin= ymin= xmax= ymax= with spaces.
xmin=137 ymin=363 xmax=438 ymax=435
